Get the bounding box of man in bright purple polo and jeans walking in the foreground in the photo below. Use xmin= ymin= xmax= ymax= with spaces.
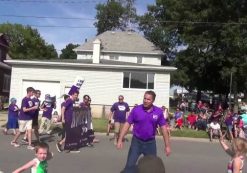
xmin=117 ymin=91 xmax=171 ymax=173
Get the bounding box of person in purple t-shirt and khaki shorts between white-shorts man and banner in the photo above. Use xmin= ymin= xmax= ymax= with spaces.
xmin=39 ymin=94 xmax=56 ymax=134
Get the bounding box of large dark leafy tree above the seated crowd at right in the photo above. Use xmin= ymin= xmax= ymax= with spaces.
xmin=140 ymin=0 xmax=247 ymax=94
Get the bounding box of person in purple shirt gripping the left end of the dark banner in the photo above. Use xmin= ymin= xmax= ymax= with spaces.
xmin=56 ymin=91 xmax=80 ymax=152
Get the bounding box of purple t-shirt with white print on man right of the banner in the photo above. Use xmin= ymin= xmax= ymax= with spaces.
xmin=111 ymin=102 xmax=130 ymax=123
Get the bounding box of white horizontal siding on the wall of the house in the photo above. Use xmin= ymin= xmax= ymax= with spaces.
xmin=10 ymin=65 xmax=170 ymax=113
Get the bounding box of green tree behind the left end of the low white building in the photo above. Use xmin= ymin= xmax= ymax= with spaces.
xmin=0 ymin=23 xmax=58 ymax=59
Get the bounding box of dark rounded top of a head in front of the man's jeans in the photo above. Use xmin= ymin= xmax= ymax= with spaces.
xmin=137 ymin=155 xmax=165 ymax=173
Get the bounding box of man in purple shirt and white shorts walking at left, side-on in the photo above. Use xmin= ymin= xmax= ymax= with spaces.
xmin=11 ymin=87 xmax=38 ymax=150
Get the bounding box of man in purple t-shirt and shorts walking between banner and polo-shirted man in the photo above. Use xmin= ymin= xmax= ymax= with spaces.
xmin=109 ymin=95 xmax=130 ymax=145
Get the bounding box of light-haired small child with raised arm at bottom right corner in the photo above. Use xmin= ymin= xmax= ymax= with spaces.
xmin=220 ymin=135 xmax=247 ymax=173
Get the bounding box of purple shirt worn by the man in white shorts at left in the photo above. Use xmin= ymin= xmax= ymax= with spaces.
xmin=19 ymin=97 xmax=34 ymax=120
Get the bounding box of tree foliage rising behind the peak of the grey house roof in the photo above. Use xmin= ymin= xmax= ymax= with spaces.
xmin=94 ymin=0 xmax=136 ymax=34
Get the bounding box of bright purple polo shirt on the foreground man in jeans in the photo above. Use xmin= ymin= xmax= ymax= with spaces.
xmin=127 ymin=104 xmax=166 ymax=141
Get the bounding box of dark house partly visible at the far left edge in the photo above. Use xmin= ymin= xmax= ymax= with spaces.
xmin=0 ymin=33 xmax=11 ymax=97
